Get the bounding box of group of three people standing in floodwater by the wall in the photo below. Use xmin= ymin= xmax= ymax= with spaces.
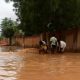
xmin=39 ymin=36 xmax=66 ymax=53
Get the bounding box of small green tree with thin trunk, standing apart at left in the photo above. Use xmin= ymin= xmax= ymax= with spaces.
xmin=1 ymin=18 xmax=17 ymax=45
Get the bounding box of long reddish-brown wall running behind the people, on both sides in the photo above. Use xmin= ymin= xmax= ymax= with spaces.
xmin=15 ymin=29 xmax=80 ymax=51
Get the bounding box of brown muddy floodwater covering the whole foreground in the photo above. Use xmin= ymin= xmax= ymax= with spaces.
xmin=0 ymin=48 xmax=80 ymax=80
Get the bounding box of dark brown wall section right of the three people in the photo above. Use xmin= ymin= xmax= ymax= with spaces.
xmin=65 ymin=29 xmax=80 ymax=51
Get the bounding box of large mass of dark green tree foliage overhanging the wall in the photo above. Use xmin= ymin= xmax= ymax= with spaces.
xmin=5 ymin=0 xmax=80 ymax=35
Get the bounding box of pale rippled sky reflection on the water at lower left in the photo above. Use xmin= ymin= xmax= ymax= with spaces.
xmin=0 ymin=52 xmax=21 ymax=80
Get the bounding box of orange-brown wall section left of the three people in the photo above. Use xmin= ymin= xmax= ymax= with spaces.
xmin=15 ymin=35 xmax=42 ymax=47
